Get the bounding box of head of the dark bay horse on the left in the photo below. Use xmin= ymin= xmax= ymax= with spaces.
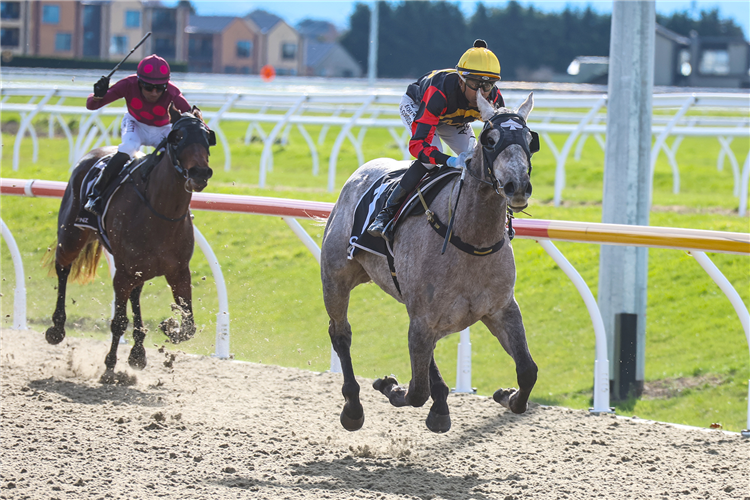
xmin=167 ymin=104 xmax=216 ymax=192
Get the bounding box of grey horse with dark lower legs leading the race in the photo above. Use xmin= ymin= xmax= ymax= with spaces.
xmin=320 ymin=94 xmax=538 ymax=432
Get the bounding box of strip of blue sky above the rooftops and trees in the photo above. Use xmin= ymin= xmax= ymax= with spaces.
xmin=170 ymin=0 xmax=750 ymax=38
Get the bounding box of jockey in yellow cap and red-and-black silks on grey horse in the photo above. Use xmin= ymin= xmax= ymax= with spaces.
xmin=367 ymin=40 xmax=505 ymax=241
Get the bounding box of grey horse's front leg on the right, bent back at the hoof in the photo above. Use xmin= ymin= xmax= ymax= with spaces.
xmin=482 ymin=299 xmax=538 ymax=413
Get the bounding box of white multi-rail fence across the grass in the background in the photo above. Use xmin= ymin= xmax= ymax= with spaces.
xmin=0 ymin=82 xmax=750 ymax=215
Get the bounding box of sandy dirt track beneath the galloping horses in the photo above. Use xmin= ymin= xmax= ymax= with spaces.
xmin=0 ymin=330 xmax=750 ymax=500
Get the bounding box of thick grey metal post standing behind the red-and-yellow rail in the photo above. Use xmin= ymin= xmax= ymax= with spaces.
xmin=599 ymin=0 xmax=656 ymax=383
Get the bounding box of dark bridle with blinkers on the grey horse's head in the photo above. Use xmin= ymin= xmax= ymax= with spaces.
xmin=466 ymin=113 xmax=539 ymax=194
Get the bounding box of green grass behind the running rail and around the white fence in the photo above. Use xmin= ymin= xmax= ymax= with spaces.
xmin=0 ymin=113 xmax=750 ymax=431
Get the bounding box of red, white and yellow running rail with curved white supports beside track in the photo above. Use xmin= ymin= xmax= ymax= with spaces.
xmin=0 ymin=178 xmax=750 ymax=436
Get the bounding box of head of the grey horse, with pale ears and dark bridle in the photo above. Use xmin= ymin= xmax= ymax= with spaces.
xmin=472 ymin=92 xmax=539 ymax=210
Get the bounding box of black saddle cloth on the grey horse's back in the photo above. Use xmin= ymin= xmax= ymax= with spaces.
xmin=348 ymin=166 xmax=461 ymax=259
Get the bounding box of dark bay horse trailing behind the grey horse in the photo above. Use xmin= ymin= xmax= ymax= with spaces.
xmin=45 ymin=106 xmax=216 ymax=383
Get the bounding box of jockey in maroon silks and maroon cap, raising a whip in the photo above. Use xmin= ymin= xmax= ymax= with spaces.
xmin=84 ymin=55 xmax=190 ymax=215
